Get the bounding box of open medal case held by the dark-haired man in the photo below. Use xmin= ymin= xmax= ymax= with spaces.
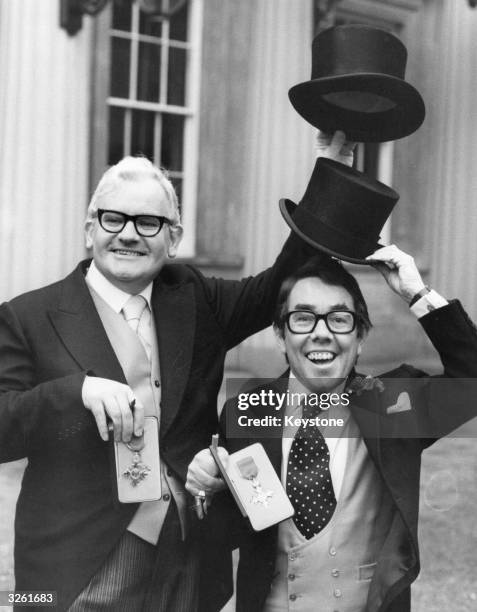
xmin=210 ymin=443 xmax=295 ymax=531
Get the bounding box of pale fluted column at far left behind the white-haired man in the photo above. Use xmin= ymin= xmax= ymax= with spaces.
xmin=0 ymin=0 xmax=91 ymax=300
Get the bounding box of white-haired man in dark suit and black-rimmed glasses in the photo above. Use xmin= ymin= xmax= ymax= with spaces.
xmin=0 ymin=140 xmax=349 ymax=612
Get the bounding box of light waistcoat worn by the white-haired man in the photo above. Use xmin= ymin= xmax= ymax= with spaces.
xmin=89 ymin=287 xmax=187 ymax=544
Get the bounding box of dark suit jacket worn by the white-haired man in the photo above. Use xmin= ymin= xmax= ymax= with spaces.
xmin=0 ymin=236 xmax=309 ymax=609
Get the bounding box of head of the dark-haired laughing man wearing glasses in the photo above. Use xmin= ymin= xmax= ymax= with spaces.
xmin=275 ymin=261 xmax=371 ymax=392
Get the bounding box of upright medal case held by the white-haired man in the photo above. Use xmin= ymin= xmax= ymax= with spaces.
xmin=113 ymin=416 xmax=161 ymax=504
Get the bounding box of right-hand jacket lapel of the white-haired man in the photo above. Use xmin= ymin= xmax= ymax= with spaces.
xmin=152 ymin=283 xmax=196 ymax=437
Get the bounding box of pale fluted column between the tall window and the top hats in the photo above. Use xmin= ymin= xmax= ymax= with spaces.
xmin=232 ymin=0 xmax=315 ymax=375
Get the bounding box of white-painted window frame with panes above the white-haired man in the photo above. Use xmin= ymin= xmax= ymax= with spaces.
xmin=89 ymin=0 xmax=203 ymax=258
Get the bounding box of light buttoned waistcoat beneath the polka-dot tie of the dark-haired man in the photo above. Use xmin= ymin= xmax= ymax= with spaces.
xmin=264 ymin=419 xmax=394 ymax=612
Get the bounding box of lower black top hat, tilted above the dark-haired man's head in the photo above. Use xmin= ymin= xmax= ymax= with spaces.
xmin=280 ymin=157 xmax=399 ymax=264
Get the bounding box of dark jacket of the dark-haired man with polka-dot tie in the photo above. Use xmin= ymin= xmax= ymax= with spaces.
xmin=210 ymin=302 xmax=477 ymax=612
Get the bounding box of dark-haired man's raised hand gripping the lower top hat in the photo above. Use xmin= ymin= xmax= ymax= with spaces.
xmin=366 ymin=244 xmax=425 ymax=304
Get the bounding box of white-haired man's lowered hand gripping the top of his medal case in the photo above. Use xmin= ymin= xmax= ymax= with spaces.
xmin=81 ymin=376 xmax=144 ymax=442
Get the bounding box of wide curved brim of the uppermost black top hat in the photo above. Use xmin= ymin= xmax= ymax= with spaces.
xmin=288 ymin=73 xmax=426 ymax=142
